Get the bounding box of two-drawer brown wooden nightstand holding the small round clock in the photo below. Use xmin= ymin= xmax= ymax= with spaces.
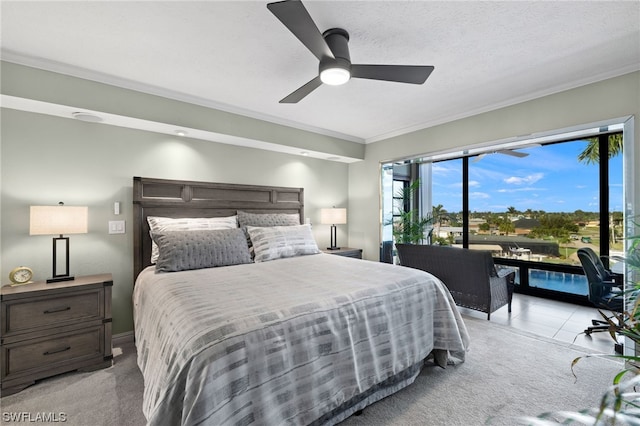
xmin=0 ymin=274 xmax=113 ymax=396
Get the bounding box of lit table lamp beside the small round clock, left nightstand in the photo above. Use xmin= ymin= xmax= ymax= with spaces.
xmin=29 ymin=202 xmax=88 ymax=283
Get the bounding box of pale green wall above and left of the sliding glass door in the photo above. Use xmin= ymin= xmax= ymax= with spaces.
xmin=349 ymin=72 xmax=640 ymax=260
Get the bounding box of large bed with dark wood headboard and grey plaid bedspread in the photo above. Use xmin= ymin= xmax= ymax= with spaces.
xmin=133 ymin=177 xmax=469 ymax=425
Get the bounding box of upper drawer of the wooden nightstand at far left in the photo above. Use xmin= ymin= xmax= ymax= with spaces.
xmin=3 ymin=289 xmax=104 ymax=335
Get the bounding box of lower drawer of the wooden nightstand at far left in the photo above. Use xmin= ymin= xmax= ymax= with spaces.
xmin=3 ymin=325 xmax=104 ymax=380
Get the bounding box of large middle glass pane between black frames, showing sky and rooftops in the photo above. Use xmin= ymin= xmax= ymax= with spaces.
xmin=469 ymin=140 xmax=600 ymax=265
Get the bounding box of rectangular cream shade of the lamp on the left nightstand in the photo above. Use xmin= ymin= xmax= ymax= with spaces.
xmin=29 ymin=206 xmax=88 ymax=235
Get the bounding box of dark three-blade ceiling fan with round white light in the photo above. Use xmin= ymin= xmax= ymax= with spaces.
xmin=267 ymin=0 xmax=434 ymax=104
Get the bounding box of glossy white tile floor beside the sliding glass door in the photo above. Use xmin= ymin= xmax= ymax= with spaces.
xmin=459 ymin=293 xmax=622 ymax=354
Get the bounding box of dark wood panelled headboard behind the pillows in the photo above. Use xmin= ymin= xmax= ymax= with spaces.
xmin=133 ymin=177 xmax=304 ymax=282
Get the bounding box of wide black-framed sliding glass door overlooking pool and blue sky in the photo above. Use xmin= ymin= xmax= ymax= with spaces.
xmin=384 ymin=128 xmax=624 ymax=302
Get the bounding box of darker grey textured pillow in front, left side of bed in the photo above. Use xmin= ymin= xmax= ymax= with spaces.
xmin=151 ymin=228 xmax=251 ymax=272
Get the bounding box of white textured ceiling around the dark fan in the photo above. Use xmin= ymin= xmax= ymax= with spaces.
xmin=1 ymin=0 xmax=640 ymax=142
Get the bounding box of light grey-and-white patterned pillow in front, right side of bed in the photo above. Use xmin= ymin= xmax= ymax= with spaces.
xmin=247 ymin=225 xmax=320 ymax=262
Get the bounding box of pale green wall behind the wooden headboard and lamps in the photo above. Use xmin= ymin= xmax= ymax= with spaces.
xmin=0 ymin=64 xmax=352 ymax=334
